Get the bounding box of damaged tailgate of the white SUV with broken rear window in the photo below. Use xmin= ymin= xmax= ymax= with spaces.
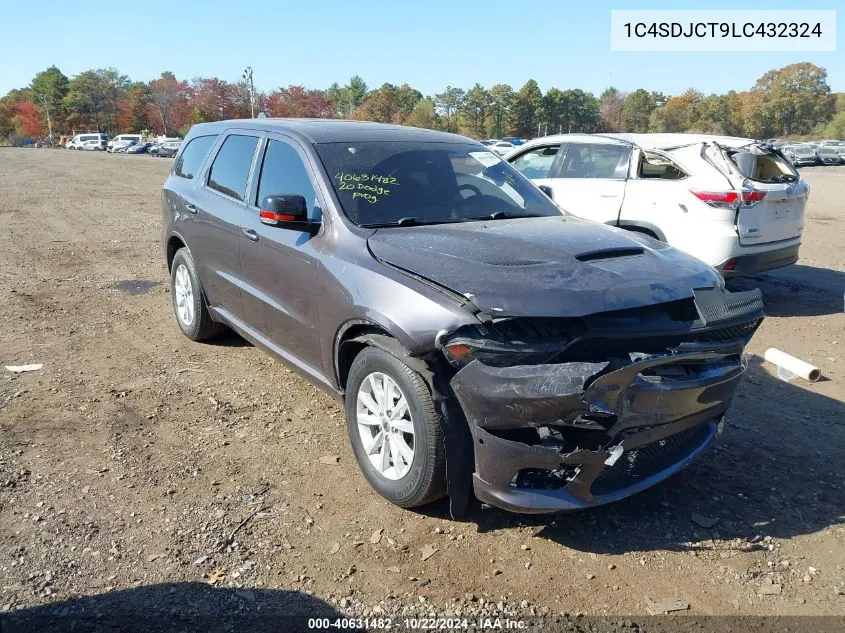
xmin=706 ymin=145 xmax=809 ymax=246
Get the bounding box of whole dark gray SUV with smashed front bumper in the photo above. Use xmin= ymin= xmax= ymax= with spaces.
xmin=162 ymin=119 xmax=763 ymax=516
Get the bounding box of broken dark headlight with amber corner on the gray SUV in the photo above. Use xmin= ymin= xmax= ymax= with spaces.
xmin=438 ymin=321 xmax=570 ymax=369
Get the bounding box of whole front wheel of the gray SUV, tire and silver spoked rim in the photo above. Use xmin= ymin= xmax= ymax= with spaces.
xmin=345 ymin=347 xmax=446 ymax=508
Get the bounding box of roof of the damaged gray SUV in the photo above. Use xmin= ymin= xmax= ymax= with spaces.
xmin=185 ymin=117 xmax=477 ymax=144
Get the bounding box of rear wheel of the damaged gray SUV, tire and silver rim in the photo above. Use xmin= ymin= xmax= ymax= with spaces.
xmin=170 ymin=248 xmax=226 ymax=341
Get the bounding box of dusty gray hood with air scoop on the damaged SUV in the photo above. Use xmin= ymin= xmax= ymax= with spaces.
xmin=368 ymin=217 xmax=721 ymax=317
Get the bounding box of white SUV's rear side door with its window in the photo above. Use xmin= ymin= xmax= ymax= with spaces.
xmin=544 ymin=142 xmax=631 ymax=225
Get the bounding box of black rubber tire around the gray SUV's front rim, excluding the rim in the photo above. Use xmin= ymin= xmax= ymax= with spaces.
xmin=344 ymin=347 xmax=446 ymax=508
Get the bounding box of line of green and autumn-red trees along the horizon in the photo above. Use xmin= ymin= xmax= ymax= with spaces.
xmin=0 ymin=62 xmax=845 ymax=143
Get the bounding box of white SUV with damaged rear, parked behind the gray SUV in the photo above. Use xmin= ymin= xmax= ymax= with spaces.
xmin=507 ymin=134 xmax=809 ymax=277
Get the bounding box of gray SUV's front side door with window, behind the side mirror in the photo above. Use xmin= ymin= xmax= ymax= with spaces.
xmin=240 ymin=133 xmax=323 ymax=373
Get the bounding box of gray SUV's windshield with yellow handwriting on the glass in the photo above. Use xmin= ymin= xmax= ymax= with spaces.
xmin=316 ymin=141 xmax=561 ymax=226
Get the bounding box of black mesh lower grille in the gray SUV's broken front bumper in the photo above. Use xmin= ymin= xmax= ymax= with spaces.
xmin=590 ymin=422 xmax=711 ymax=495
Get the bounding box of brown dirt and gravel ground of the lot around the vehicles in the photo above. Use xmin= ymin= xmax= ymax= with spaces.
xmin=0 ymin=148 xmax=845 ymax=627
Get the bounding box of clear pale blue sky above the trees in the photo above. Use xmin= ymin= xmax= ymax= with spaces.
xmin=0 ymin=0 xmax=845 ymax=95
